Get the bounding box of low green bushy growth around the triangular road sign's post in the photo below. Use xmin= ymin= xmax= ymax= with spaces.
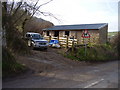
xmin=65 ymin=44 xmax=117 ymax=61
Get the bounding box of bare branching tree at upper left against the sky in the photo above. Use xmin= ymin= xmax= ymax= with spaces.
xmin=2 ymin=0 xmax=57 ymax=45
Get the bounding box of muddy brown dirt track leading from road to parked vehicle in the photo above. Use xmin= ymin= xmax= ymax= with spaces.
xmin=18 ymin=48 xmax=91 ymax=72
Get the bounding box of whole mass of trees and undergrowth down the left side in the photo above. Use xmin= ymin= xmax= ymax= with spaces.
xmin=0 ymin=0 xmax=53 ymax=77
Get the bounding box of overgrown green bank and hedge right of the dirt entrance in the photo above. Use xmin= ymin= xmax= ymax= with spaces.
xmin=63 ymin=32 xmax=120 ymax=61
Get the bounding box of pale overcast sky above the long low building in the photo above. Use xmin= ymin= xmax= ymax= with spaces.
xmin=35 ymin=0 xmax=119 ymax=32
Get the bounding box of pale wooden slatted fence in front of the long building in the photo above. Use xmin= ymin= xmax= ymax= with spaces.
xmin=44 ymin=36 xmax=78 ymax=47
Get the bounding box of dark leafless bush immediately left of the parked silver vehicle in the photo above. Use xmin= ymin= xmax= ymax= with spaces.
xmin=6 ymin=28 xmax=30 ymax=54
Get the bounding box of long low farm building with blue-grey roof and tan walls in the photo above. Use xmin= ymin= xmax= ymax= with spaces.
xmin=43 ymin=23 xmax=108 ymax=44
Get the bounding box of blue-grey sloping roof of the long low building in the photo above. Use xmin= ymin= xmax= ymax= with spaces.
xmin=43 ymin=23 xmax=108 ymax=31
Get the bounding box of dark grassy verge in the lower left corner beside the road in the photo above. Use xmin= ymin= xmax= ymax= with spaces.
xmin=2 ymin=47 xmax=26 ymax=78
